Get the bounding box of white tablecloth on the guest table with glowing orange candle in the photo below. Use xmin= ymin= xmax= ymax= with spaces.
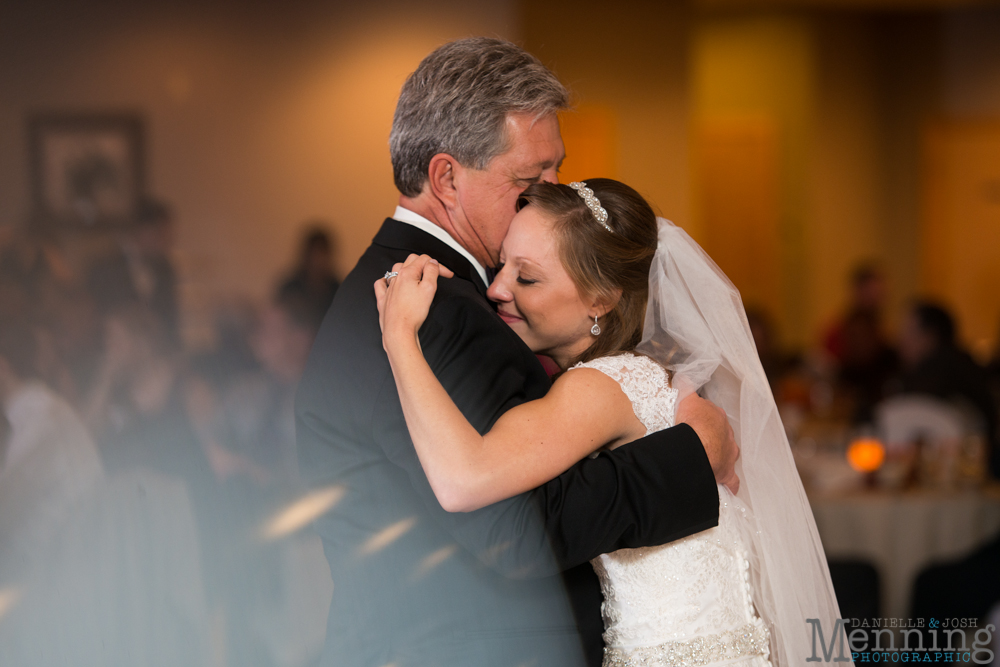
xmin=810 ymin=487 xmax=1000 ymax=618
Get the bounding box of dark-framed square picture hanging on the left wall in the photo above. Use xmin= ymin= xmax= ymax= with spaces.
xmin=28 ymin=113 xmax=144 ymax=229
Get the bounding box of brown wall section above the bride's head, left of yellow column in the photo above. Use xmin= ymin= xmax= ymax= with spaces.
xmin=521 ymin=0 xmax=691 ymax=224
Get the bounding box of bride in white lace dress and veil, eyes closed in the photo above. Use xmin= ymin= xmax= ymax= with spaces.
xmin=375 ymin=179 xmax=839 ymax=667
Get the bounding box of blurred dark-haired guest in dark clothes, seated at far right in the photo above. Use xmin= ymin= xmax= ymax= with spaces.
xmin=892 ymin=301 xmax=998 ymax=474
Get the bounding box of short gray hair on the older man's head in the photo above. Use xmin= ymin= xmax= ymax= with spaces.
xmin=389 ymin=37 xmax=569 ymax=197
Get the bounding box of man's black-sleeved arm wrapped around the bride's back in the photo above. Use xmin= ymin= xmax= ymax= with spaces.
xmin=374 ymin=290 xmax=718 ymax=576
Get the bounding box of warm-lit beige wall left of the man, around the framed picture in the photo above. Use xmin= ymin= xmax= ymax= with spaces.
xmin=0 ymin=0 xmax=518 ymax=339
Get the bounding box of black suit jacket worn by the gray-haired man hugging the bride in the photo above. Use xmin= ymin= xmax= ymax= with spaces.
xmin=296 ymin=219 xmax=719 ymax=667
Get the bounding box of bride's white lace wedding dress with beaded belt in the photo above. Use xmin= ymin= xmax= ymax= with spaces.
xmin=575 ymin=354 xmax=771 ymax=667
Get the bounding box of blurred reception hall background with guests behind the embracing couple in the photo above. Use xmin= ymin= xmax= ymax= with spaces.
xmin=0 ymin=0 xmax=1000 ymax=666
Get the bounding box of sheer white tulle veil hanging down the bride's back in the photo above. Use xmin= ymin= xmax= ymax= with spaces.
xmin=638 ymin=218 xmax=844 ymax=667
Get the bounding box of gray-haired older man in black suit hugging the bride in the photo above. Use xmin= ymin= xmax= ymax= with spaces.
xmin=296 ymin=38 xmax=736 ymax=667
